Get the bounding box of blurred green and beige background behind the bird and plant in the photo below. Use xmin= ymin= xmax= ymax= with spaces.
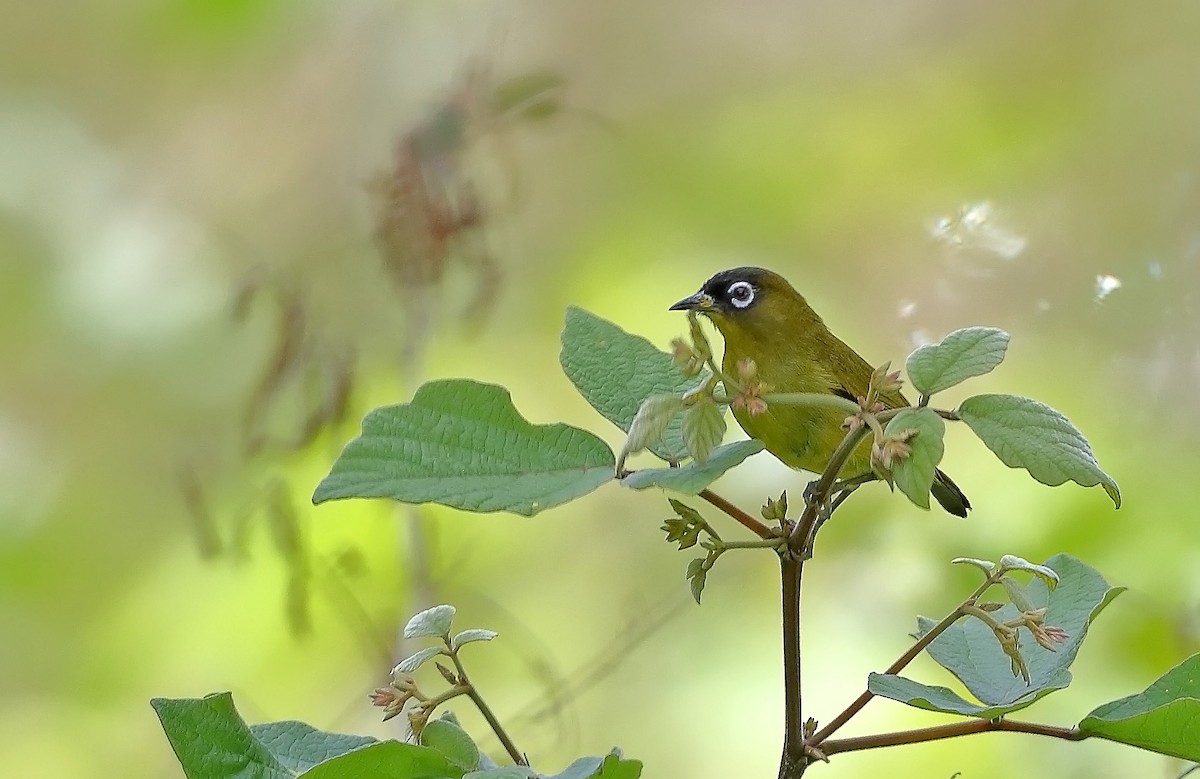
xmin=0 ymin=0 xmax=1200 ymax=778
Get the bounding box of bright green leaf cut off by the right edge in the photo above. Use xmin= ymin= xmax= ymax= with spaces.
xmin=1079 ymin=654 xmax=1200 ymax=762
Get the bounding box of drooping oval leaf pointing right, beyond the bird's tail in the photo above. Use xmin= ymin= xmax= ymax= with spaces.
xmin=958 ymin=395 xmax=1121 ymax=509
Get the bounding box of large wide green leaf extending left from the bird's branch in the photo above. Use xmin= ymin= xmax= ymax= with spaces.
xmin=312 ymin=379 xmax=616 ymax=516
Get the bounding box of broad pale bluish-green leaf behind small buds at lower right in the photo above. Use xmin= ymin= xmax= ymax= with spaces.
xmin=918 ymin=555 xmax=1123 ymax=711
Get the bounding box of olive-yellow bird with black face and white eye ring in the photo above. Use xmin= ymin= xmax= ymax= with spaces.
xmin=671 ymin=266 xmax=971 ymax=517
